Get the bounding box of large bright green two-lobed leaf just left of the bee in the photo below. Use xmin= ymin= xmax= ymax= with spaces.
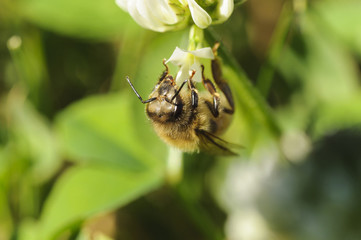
xmin=47 ymin=87 xmax=166 ymax=239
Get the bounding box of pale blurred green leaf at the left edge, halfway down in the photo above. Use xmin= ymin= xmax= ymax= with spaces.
xmin=0 ymin=88 xmax=60 ymax=183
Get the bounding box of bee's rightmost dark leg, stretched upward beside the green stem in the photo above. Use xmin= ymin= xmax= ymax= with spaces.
xmin=211 ymin=43 xmax=234 ymax=114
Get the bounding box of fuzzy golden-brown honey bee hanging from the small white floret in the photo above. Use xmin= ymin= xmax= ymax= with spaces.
xmin=126 ymin=45 xmax=235 ymax=155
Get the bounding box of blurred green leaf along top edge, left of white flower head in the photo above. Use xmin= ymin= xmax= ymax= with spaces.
xmin=19 ymin=0 xmax=141 ymax=39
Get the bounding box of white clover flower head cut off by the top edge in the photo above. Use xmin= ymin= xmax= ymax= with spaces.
xmin=115 ymin=0 xmax=234 ymax=32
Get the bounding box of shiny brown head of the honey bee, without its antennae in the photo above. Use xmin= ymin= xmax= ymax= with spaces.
xmin=146 ymin=75 xmax=182 ymax=123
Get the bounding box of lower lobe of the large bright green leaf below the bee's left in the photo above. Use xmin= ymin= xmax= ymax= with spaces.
xmin=38 ymin=166 xmax=163 ymax=239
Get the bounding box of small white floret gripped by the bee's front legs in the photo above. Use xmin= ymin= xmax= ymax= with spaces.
xmin=166 ymin=47 xmax=214 ymax=82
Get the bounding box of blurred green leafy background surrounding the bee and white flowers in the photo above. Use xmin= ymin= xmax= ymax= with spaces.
xmin=0 ymin=0 xmax=361 ymax=240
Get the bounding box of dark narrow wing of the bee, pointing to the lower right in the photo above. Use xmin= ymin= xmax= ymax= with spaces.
xmin=196 ymin=130 xmax=242 ymax=156
